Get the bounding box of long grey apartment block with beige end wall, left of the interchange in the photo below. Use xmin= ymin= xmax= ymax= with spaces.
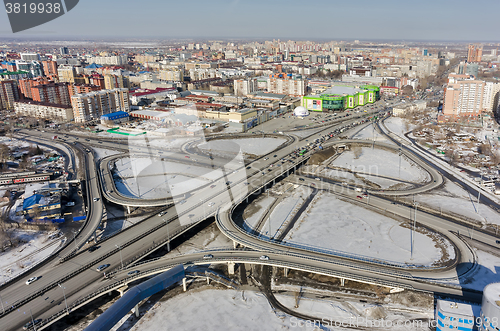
xmin=71 ymin=88 xmax=130 ymax=123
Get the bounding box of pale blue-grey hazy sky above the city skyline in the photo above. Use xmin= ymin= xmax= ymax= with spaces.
xmin=0 ymin=0 xmax=500 ymax=41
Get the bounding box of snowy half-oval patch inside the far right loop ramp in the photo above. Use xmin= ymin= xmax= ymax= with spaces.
xmin=331 ymin=147 xmax=430 ymax=183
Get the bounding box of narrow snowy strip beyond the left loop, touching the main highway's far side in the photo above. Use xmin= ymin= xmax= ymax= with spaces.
xmin=198 ymin=138 xmax=286 ymax=155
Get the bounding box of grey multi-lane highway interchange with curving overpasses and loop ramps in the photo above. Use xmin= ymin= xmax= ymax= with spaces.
xmin=0 ymin=102 xmax=497 ymax=330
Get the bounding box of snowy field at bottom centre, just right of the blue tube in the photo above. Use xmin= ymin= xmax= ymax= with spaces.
xmin=127 ymin=289 xmax=315 ymax=331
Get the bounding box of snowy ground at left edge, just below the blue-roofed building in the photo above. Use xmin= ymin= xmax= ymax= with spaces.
xmin=0 ymin=230 xmax=64 ymax=283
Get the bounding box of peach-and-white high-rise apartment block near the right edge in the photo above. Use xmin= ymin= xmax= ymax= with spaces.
xmin=443 ymin=74 xmax=485 ymax=118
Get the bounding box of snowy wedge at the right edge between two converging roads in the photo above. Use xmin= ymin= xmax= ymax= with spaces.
xmin=415 ymin=180 xmax=500 ymax=225
